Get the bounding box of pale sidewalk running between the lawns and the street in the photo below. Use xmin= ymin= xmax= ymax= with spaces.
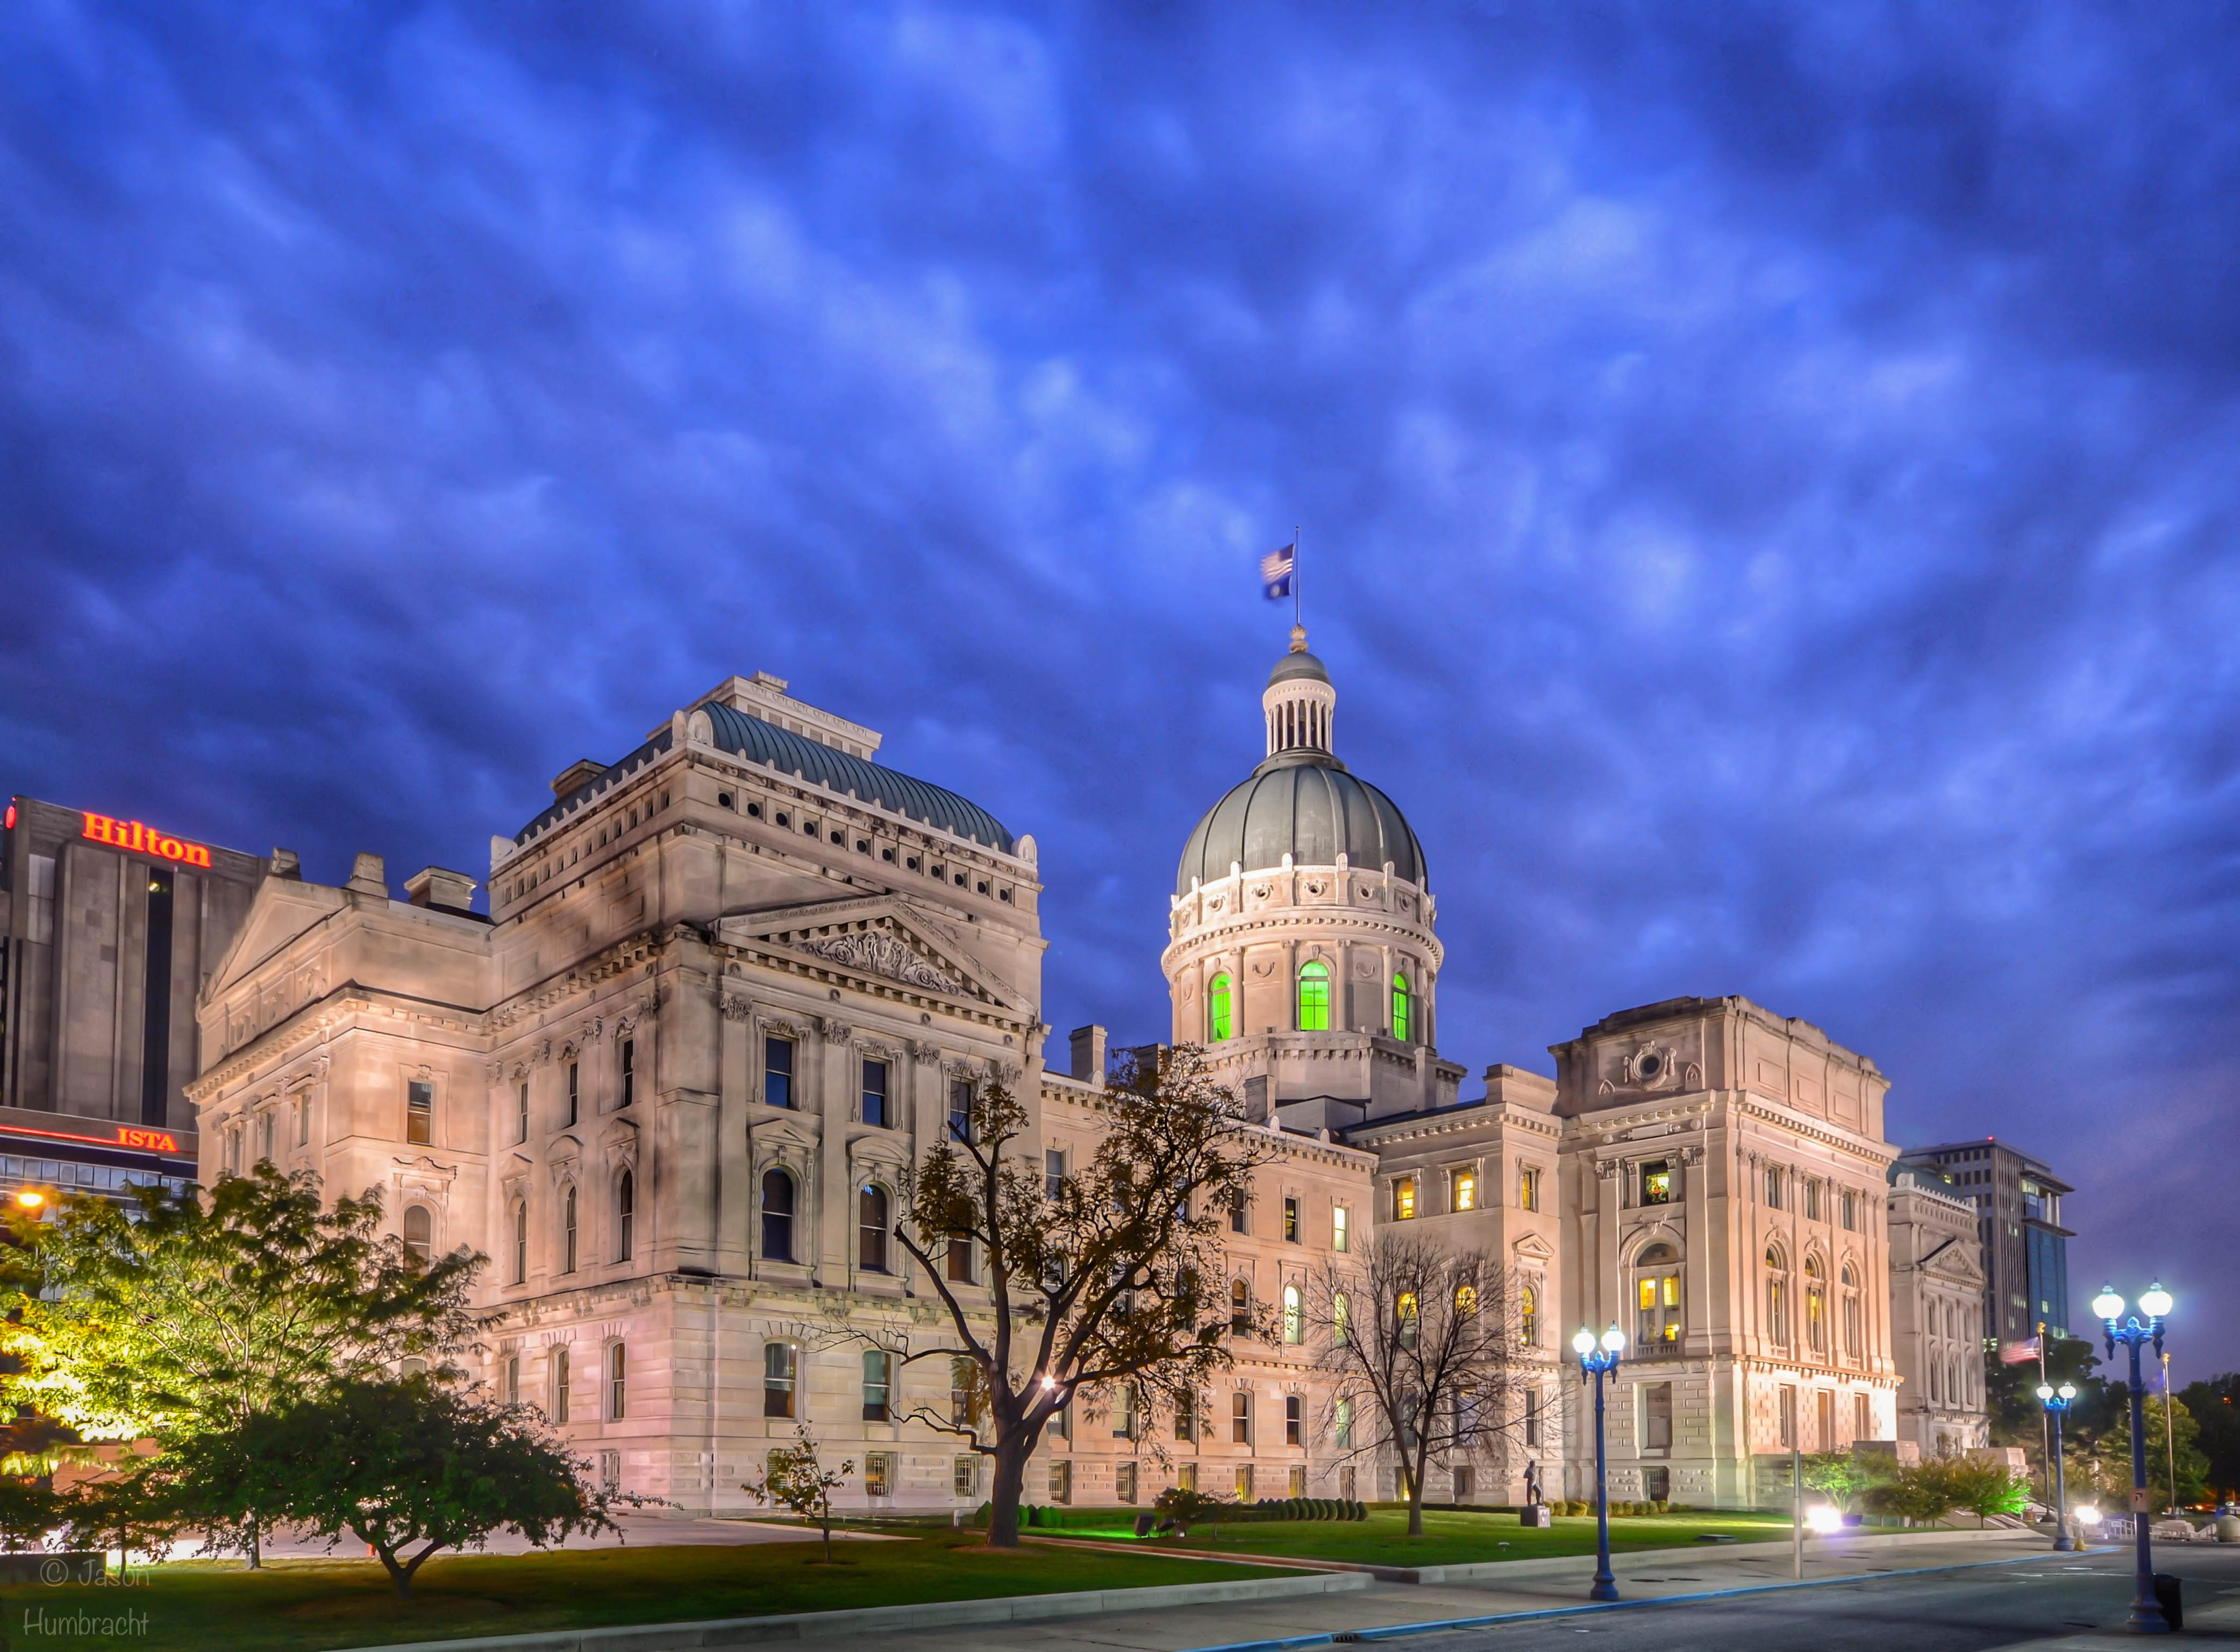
xmin=860 ymin=1533 xmax=2079 ymax=1652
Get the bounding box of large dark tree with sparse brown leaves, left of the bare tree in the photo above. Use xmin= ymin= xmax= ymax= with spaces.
xmin=882 ymin=1044 xmax=1274 ymax=1549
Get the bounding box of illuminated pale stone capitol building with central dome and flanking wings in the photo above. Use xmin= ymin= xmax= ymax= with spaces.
xmin=188 ymin=630 xmax=1926 ymax=1513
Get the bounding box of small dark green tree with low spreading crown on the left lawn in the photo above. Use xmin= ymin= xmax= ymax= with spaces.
xmin=159 ymin=1374 xmax=613 ymax=1600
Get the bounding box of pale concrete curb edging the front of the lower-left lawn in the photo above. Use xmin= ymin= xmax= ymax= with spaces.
xmin=349 ymin=1571 xmax=1371 ymax=1652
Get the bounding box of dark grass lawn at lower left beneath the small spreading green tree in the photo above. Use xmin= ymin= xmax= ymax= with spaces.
xmin=0 ymin=1531 xmax=1277 ymax=1652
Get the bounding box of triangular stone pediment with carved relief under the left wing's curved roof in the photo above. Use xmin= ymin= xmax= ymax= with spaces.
xmin=717 ymin=894 xmax=1033 ymax=1015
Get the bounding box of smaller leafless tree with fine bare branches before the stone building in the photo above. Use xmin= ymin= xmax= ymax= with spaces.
xmin=1308 ymin=1230 xmax=1523 ymax=1537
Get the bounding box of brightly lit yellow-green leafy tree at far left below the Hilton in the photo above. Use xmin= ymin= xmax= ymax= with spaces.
xmin=0 ymin=1161 xmax=484 ymax=1564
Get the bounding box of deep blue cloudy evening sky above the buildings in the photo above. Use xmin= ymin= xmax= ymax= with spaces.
xmin=0 ymin=0 xmax=2240 ymax=1381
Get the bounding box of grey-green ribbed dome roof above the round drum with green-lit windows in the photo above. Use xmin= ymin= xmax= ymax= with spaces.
xmin=1174 ymin=753 xmax=1425 ymax=894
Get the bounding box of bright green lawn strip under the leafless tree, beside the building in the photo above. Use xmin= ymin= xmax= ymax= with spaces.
xmin=1035 ymin=1508 xmax=1790 ymax=1567
